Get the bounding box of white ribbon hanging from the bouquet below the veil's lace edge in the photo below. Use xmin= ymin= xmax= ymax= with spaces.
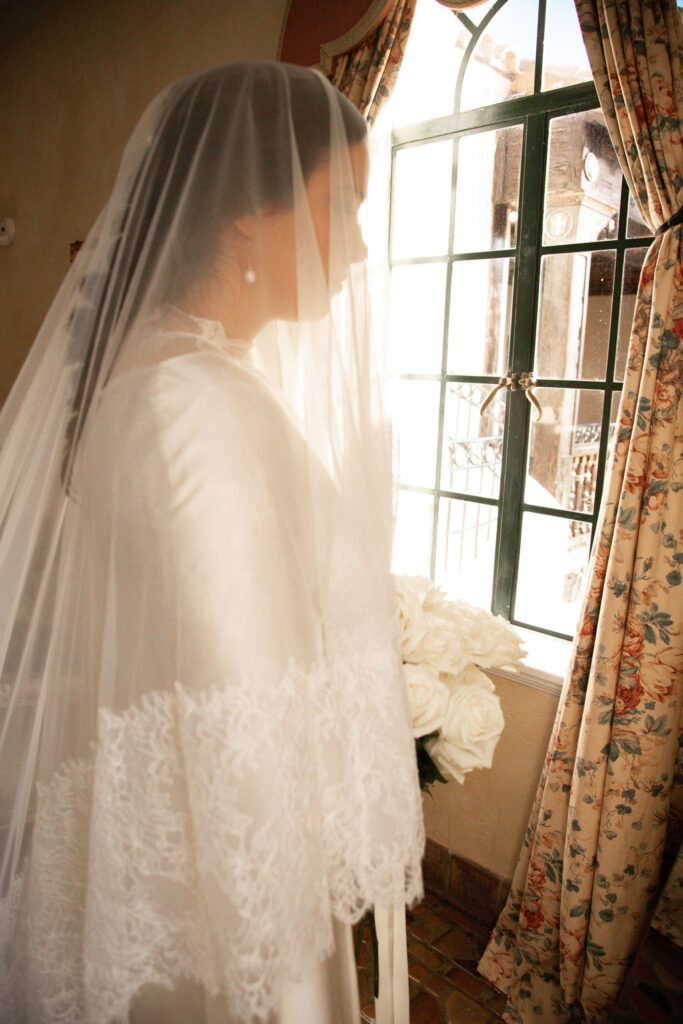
xmin=375 ymin=903 xmax=411 ymax=1024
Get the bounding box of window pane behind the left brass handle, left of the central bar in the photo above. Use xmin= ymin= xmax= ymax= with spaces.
xmin=441 ymin=384 xmax=505 ymax=498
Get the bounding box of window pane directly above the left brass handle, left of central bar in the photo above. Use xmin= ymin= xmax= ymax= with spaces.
xmin=448 ymin=257 xmax=515 ymax=377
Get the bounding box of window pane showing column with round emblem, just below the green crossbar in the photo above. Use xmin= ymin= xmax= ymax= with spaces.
xmin=543 ymin=110 xmax=622 ymax=246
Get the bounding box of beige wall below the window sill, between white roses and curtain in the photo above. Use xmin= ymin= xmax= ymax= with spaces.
xmin=423 ymin=675 xmax=558 ymax=879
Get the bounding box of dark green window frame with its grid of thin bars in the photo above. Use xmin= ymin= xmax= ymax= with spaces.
xmin=389 ymin=0 xmax=651 ymax=640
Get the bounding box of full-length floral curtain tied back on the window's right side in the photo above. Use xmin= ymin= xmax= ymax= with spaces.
xmin=479 ymin=0 xmax=683 ymax=1024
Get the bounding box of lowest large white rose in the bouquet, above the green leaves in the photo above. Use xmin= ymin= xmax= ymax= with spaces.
xmin=426 ymin=670 xmax=505 ymax=782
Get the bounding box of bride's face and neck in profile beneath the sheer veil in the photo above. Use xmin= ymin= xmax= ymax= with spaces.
xmin=253 ymin=142 xmax=368 ymax=319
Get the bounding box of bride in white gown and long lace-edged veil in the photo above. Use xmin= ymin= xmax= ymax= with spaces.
xmin=0 ymin=61 xmax=424 ymax=1024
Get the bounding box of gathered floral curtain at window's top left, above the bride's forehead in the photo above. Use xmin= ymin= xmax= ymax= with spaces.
xmin=329 ymin=0 xmax=417 ymax=125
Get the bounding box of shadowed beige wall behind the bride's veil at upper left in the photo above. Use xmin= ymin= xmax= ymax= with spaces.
xmin=0 ymin=0 xmax=288 ymax=403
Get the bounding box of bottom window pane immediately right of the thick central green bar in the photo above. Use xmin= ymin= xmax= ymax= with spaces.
xmin=514 ymin=512 xmax=591 ymax=635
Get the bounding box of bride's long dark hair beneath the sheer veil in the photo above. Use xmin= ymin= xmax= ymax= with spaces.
xmin=62 ymin=61 xmax=367 ymax=483
